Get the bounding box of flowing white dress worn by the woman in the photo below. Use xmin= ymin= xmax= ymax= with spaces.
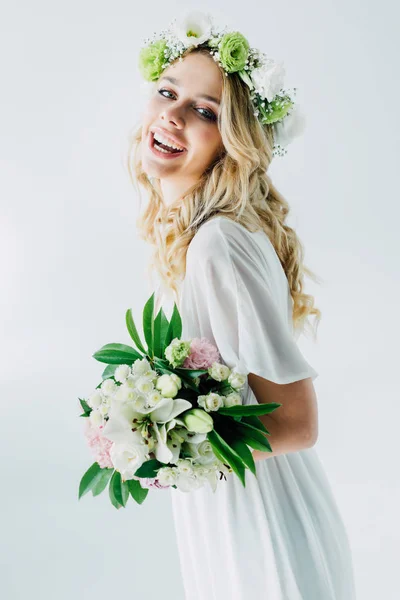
xmin=153 ymin=216 xmax=356 ymax=600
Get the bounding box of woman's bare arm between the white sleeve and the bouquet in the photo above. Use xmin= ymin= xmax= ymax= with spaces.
xmin=248 ymin=373 xmax=318 ymax=460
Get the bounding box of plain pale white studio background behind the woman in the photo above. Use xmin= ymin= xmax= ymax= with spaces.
xmin=0 ymin=0 xmax=400 ymax=600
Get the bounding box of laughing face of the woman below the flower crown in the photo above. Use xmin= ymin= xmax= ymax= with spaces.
xmin=142 ymin=53 xmax=223 ymax=184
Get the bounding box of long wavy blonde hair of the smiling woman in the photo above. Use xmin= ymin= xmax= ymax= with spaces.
xmin=126 ymin=46 xmax=321 ymax=337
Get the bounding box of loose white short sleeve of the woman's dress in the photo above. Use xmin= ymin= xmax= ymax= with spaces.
xmin=182 ymin=223 xmax=318 ymax=384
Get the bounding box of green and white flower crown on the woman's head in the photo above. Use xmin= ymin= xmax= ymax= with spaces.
xmin=139 ymin=11 xmax=305 ymax=156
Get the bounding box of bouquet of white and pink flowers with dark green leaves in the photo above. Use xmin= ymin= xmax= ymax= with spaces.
xmin=79 ymin=293 xmax=281 ymax=509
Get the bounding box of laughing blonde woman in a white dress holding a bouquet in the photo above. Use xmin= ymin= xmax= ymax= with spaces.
xmin=129 ymin=9 xmax=355 ymax=600
